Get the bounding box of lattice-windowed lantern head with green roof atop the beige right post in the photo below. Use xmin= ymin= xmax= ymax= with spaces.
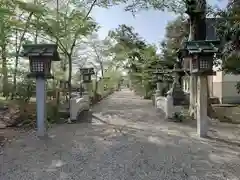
xmin=184 ymin=40 xmax=220 ymax=75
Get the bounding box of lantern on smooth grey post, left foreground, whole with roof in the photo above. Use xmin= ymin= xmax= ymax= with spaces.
xmin=21 ymin=44 xmax=60 ymax=137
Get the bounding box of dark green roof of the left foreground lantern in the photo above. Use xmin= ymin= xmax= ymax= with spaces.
xmin=22 ymin=44 xmax=60 ymax=61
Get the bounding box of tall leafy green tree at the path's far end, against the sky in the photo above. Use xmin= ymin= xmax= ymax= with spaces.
xmin=109 ymin=25 xmax=163 ymax=97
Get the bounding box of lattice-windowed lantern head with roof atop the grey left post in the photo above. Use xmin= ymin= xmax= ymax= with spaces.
xmin=22 ymin=44 xmax=60 ymax=78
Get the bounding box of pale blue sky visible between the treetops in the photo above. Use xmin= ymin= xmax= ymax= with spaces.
xmin=92 ymin=0 xmax=227 ymax=45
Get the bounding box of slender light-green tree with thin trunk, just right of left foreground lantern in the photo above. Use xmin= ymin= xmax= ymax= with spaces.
xmin=29 ymin=2 xmax=97 ymax=95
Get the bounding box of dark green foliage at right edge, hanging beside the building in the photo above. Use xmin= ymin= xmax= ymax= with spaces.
xmin=217 ymin=0 xmax=240 ymax=74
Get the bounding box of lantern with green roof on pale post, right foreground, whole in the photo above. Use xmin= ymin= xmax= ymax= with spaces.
xmin=181 ymin=40 xmax=220 ymax=137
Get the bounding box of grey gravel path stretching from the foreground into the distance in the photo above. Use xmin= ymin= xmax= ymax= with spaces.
xmin=0 ymin=90 xmax=240 ymax=180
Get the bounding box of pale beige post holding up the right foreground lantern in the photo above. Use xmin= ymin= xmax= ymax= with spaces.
xmin=197 ymin=76 xmax=208 ymax=137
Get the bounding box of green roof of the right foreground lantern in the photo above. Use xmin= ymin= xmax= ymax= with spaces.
xmin=183 ymin=40 xmax=221 ymax=56
